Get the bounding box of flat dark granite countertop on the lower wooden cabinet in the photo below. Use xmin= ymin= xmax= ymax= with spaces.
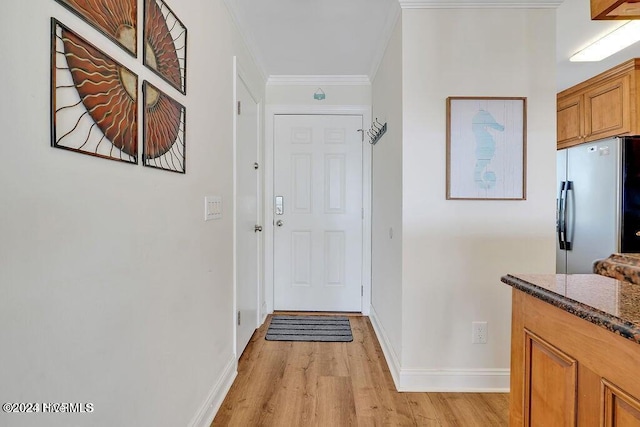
xmin=501 ymin=274 xmax=640 ymax=344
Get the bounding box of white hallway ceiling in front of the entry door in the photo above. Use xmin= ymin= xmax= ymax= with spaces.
xmin=227 ymin=0 xmax=399 ymax=76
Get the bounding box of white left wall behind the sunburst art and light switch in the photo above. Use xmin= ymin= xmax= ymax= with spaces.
xmin=0 ymin=0 xmax=262 ymax=426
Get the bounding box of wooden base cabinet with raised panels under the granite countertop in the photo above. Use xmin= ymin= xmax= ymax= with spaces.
xmin=510 ymin=289 xmax=640 ymax=427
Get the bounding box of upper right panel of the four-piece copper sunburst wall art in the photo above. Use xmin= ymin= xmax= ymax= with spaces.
xmin=142 ymin=0 xmax=187 ymax=94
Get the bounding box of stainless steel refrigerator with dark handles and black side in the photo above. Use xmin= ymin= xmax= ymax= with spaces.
xmin=556 ymin=137 xmax=640 ymax=274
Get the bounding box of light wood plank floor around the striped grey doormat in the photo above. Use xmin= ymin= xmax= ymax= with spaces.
xmin=211 ymin=316 xmax=509 ymax=427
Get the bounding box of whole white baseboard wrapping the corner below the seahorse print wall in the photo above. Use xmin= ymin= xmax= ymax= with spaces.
xmin=369 ymin=307 xmax=510 ymax=393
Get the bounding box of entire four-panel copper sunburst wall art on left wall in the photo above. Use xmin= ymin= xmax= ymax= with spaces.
xmin=51 ymin=0 xmax=187 ymax=173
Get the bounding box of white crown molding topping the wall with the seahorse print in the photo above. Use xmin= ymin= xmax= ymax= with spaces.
xmin=398 ymin=0 xmax=563 ymax=9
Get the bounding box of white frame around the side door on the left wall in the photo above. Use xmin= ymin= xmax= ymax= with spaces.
xmin=232 ymin=56 xmax=266 ymax=360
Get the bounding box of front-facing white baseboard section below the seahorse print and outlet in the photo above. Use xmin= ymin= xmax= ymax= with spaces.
xmin=398 ymin=369 xmax=510 ymax=393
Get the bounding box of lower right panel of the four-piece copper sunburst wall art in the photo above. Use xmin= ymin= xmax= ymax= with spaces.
xmin=142 ymin=80 xmax=186 ymax=173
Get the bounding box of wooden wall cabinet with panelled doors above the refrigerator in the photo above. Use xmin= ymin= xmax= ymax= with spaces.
xmin=557 ymin=59 xmax=640 ymax=149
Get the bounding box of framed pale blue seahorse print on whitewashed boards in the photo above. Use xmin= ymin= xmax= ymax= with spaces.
xmin=447 ymin=97 xmax=527 ymax=200
